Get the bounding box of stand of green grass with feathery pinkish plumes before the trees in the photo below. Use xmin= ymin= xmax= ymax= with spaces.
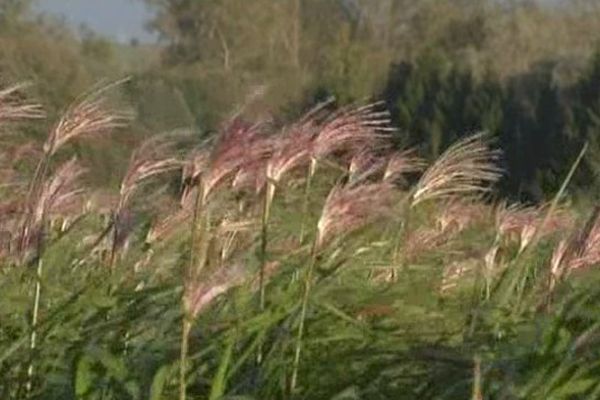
xmin=0 ymin=81 xmax=600 ymax=399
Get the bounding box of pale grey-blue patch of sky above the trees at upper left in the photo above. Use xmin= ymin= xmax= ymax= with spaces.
xmin=35 ymin=0 xmax=155 ymax=42
